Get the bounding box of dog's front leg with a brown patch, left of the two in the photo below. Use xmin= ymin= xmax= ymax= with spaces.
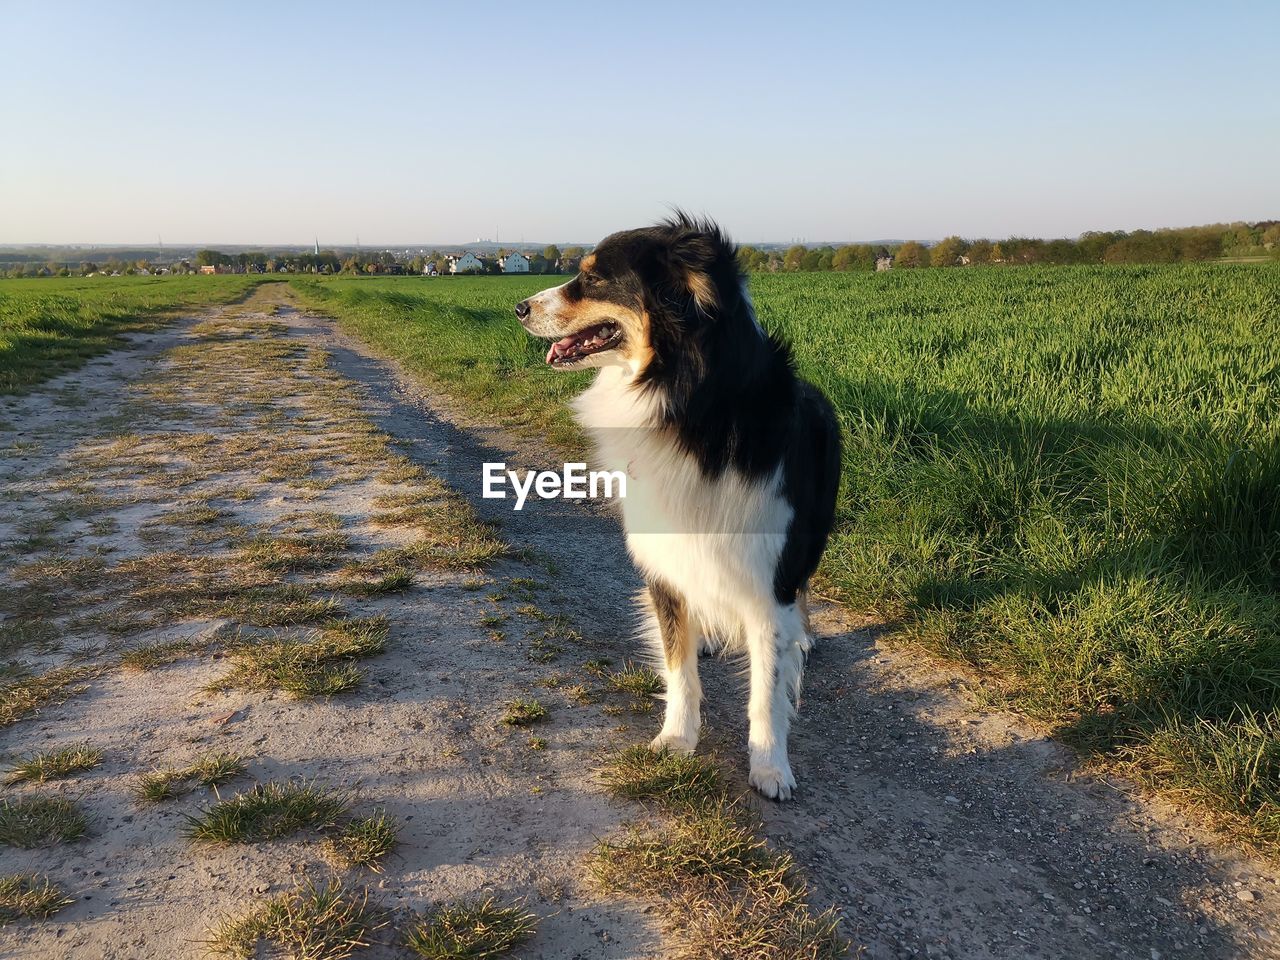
xmin=648 ymin=581 xmax=703 ymax=753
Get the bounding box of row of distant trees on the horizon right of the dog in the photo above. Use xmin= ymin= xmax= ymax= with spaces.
xmin=739 ymin=220 xmax=1280 ymax=273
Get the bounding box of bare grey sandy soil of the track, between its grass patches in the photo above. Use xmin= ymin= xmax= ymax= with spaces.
xmin=0 ymin=289 xmax=1280 ymax=960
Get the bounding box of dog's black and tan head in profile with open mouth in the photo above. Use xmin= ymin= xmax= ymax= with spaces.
xmin=516 ymin=214 xmax=742 ymax=374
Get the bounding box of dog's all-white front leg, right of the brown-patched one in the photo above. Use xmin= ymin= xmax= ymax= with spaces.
xmin=746 ymin=604 xmax=805 ymax=800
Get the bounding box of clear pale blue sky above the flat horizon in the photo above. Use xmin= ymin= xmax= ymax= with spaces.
xmin=0 ymin=0 xmax=1280 ymax=244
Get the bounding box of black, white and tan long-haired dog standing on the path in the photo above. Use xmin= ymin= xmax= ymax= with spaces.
xmin=516 ymin=214 xmax=840 ymax=800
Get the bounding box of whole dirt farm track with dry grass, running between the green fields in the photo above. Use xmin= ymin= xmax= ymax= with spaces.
xmin=0 ymin=294 xmax=1280 ymax=960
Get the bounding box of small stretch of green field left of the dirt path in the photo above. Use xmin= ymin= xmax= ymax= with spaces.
xmin=0 ymin=276 xmax=257 ymax=394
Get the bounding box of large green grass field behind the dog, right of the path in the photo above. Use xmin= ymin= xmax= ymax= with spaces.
xmin=294 ymin=264 xmax=1280 ymax=849
